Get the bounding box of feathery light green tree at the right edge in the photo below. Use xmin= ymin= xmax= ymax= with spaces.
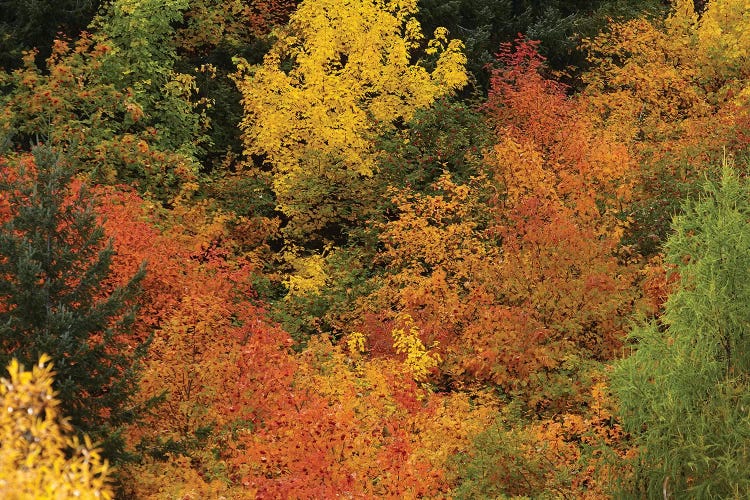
xmin=612 ymin=162 xmax=750 ymax=498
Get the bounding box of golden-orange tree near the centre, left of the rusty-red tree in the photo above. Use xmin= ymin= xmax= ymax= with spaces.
xmin=362 ymin=173 xmax=500 ymax=360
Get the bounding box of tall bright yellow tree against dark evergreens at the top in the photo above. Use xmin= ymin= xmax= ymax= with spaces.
xmin=235 ymin=0 xmax=467 ymax=254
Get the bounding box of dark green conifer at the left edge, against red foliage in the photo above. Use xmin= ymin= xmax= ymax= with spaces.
xmin=0 ymin=146 xmax=148 ymax=459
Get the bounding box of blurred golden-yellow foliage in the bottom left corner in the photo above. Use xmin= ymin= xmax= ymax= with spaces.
xmin=0 ymin=355 xmax=112 ymax=500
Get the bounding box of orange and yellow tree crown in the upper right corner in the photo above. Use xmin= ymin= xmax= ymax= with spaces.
xmin=584 ymin=0 xmax=749 ymax=147
